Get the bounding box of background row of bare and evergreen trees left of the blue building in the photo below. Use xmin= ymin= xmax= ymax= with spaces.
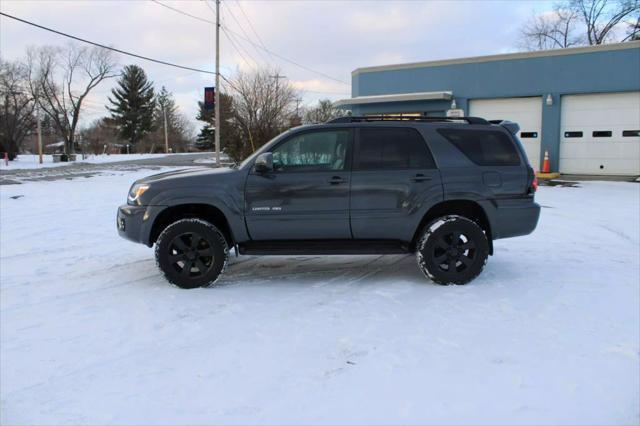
xmin=0 ymin=43 xmax=344 ymax=161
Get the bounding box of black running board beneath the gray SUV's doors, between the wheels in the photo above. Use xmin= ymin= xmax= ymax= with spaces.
xmin=238 ymin=240 xmax=409 ymax=256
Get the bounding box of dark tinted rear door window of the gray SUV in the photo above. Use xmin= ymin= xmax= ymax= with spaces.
xmin=354 ymin=127 xmax=435 ymax=170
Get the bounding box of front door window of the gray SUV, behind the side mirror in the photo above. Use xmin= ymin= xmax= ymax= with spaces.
xmin=273 ymin=130 xmax=350 ymax=172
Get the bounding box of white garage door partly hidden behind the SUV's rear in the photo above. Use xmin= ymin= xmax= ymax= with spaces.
xmin=469 ymin=97 xmax=542 ymax=170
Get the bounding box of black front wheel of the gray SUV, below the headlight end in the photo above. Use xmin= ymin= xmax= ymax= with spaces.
xmin=155 ymin=219 xmax=229 ymax=289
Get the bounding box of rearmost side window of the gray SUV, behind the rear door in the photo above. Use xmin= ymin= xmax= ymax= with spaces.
xmin=438 ymin=129 xmax=520 ymax=166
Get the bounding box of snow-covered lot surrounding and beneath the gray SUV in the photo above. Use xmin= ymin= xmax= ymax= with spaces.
xmin=0 ymin=171 xmax=640 ymax=425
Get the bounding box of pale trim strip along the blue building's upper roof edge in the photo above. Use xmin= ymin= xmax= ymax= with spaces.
xmin=351 ymin=41 xmax=640 ymax=76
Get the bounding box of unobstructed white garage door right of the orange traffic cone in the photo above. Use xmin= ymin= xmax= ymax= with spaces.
xmin=560 ymin=92 xmax=640 ymax=175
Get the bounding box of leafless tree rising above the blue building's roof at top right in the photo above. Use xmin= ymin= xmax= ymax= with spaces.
xmin=520 ymin=0 xmax=640 ymax=50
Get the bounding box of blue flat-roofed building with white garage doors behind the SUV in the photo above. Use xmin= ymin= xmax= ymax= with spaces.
xmin=337 ymin=41 xmax=640 ymax=175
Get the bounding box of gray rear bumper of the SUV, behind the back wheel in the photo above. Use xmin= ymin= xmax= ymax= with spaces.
xmin=485 ymin=199 xmax=540 ymax=240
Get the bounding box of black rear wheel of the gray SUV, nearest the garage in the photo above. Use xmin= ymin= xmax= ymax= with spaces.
xmin=416 ymin=216 xmax=489 ymax=285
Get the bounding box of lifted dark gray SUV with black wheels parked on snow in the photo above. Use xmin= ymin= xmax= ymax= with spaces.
xmin=117 ymin=116 xmax=540 ymax=288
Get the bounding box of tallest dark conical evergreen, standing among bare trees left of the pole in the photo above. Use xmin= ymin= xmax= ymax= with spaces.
xmin=108 ymin=65 xmax=156 ymax=146
